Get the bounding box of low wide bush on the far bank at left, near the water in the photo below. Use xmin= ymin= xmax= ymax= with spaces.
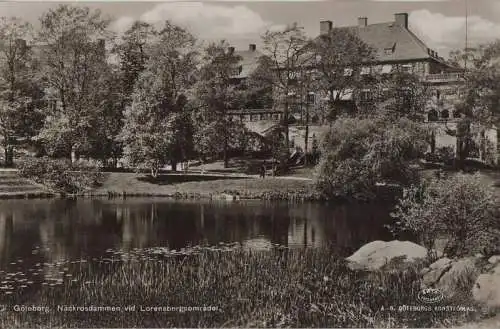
xmin=19 ymin=157 xmax=103 ymax=194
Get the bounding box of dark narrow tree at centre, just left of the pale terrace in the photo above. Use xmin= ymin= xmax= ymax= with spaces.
xmin=194 ymin=41 xmax=244 ymax=167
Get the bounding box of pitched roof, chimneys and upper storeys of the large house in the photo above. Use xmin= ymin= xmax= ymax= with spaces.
xmin=314 ymin=13 xmax=463 ymax=121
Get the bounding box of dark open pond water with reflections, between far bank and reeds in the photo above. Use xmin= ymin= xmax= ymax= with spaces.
xmin=0 ymin=199 xmax=390 ymax=270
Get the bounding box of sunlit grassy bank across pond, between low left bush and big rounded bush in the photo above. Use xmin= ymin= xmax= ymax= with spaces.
xmin=89 ymin=173 xmax=316 ymax=200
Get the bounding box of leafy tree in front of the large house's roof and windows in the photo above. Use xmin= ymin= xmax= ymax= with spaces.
xmin=309 ymin=28 xmax=377 ymax=119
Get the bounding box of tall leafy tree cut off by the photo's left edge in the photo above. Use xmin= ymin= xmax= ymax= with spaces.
xmin=0 ymin=17 xmax=36 ymax=166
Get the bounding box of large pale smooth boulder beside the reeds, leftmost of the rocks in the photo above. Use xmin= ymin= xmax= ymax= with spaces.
xmin=346 ymin=240 xmax=427 ymax=271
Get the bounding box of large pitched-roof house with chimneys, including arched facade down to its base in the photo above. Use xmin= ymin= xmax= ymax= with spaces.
xmin=316 ymin=13 xmax=498 ymax=163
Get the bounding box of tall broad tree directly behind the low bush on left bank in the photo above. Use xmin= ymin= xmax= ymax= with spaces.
xmin=37 ymin=5 xmax=109 ymax=161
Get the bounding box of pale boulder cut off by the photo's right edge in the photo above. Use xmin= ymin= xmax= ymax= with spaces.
xmin=472 ymin=263 xmax=500 ymax=308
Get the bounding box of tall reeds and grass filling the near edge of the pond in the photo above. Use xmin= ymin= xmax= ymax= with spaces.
xmin=0 ymin=248 xmax=484 ymax=328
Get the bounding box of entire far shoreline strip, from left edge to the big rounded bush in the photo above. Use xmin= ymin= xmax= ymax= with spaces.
xmin=0 ymin=172 xmax=321 ymax=201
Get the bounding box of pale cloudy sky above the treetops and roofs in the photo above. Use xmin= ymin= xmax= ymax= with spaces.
xmin=0 ymin=0 xmax=500 ymax=57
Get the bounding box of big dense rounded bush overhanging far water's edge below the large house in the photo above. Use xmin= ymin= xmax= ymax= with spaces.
xmin=316 ymin=117 xmax=427 ymax=198
